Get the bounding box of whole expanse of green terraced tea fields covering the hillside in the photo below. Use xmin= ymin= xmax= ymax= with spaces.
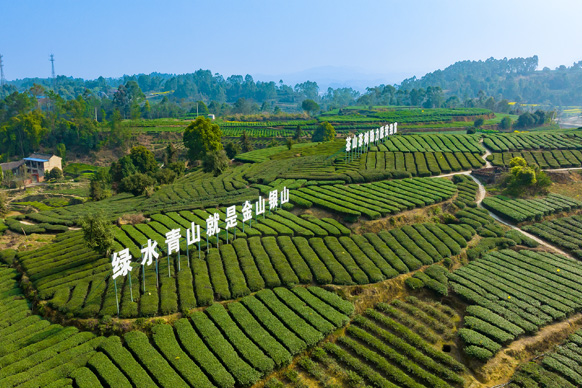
xmin=5 ymin=111 xmax=582 ymax=388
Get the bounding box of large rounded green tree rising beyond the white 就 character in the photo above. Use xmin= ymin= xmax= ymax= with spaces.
xmin=184 ymin=116 xmax=222 ymax=160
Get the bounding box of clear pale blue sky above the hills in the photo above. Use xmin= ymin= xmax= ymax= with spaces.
xmin=0 ymin=0 xmax=582 ymax=83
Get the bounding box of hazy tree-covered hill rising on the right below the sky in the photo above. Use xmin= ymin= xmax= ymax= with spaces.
xmin=399 ymin=55 xmax=582 ymax=105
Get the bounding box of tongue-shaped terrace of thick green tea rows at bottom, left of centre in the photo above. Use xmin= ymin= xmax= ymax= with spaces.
xmin=68 ymin=287 xmax=354 ymax=388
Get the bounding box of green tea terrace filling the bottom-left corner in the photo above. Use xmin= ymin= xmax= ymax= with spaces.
xmin=0 ymin=266 xmax=105 ymax=388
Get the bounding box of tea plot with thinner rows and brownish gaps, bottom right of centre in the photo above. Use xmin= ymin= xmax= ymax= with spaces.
xmin=267 ymin=297 xmax=464 ymax=388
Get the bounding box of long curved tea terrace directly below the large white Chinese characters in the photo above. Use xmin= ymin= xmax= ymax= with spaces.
xmin=17 ymin=213 xmax=473 ymax=318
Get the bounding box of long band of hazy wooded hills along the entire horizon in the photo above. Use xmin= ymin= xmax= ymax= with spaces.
xmin=0 ymin=55 xmax=582 ymax=106
